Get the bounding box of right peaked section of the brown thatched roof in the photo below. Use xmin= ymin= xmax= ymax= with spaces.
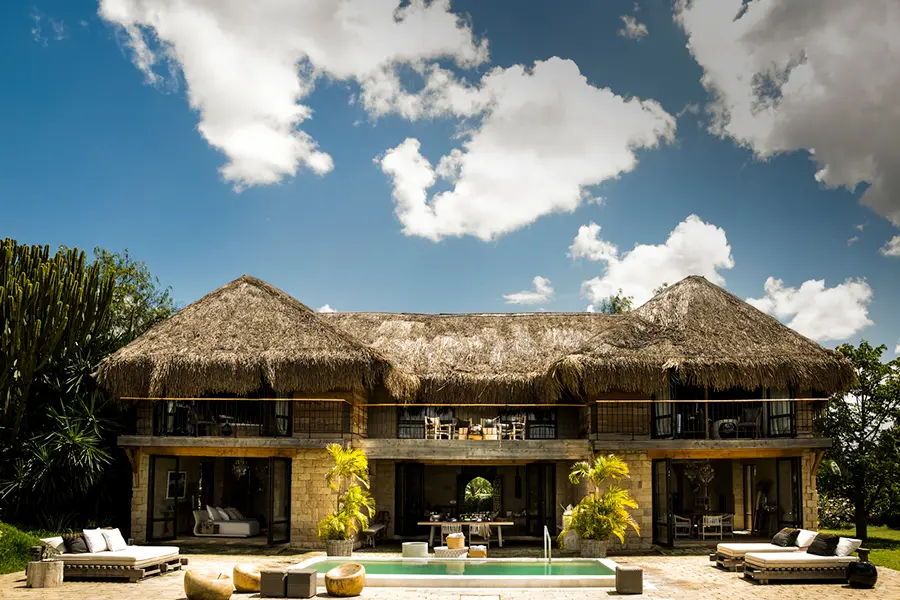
xmin=551 ymin=276 xmax=854 ymax=397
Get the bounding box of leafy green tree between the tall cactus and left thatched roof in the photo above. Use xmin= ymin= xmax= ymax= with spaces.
xmin=94 ymin=248 xmax=176 ymax=352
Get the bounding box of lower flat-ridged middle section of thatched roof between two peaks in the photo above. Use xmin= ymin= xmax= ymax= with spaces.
xmin=322 ymin=313 xmax=615 ymax=404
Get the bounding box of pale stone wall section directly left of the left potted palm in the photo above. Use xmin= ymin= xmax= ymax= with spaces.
xmin=291 ymin=449 xmax=336 ymax=549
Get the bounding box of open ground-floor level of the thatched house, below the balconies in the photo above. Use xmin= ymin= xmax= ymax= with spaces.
xmin=131 ymin=447 xmax=818 ymax=551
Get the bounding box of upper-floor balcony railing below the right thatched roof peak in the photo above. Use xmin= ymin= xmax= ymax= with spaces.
xmin=589 ymin=398 xmax=824 ymax=440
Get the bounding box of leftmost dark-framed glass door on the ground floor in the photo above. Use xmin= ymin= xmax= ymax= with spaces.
xmin=147 ymin=456 xmax=180 ymax=541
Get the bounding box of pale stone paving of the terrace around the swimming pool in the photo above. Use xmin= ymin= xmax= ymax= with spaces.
xmin=0 ymin=555 xmax=900 ymax=600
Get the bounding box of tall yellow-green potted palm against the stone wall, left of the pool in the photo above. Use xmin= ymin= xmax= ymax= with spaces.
xmin=318 ymin=444 xmax=375 ymax=556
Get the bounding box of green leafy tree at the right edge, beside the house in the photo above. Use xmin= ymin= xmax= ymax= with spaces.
xmin=819 ymin=340 xmax=900 ymax=540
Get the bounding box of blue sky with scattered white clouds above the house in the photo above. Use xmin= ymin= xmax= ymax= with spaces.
xmin=0 ymin=0 xmax=900 ymax=357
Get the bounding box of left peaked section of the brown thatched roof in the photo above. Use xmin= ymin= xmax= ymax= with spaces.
xmin=98 ymin=275 xmax=415 ymax=398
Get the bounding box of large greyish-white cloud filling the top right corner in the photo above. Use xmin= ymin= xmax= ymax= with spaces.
xmin=676 ymin=0 xmax=900 ymax=226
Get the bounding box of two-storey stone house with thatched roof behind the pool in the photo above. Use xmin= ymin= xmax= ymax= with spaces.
xmin=99 ymin=276 xmax=853 ymax=548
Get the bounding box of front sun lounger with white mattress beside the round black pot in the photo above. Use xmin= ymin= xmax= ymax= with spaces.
xmin=744 ymin=548 xmax=869 ymax=583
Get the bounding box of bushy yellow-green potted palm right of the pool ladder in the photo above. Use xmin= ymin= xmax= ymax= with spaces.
xmin=557 ymin=454 xmax=640 ymax=558
